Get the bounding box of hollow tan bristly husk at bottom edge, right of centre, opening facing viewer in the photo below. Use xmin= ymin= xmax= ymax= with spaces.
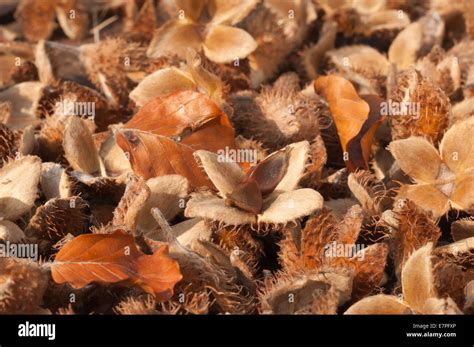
xmin=258 ymin=272 xmax=352 ymax=314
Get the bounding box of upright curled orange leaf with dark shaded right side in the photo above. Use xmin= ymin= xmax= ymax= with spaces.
xmin=314 ymin=75 xmax=382 ymax=171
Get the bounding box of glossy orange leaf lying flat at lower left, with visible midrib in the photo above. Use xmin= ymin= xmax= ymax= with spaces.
xmin=51 ymin=231 xmax=182 ymax=299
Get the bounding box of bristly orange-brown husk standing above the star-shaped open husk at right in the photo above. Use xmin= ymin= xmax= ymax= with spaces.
xmin=390 ymin=68 xmax=450 ymax=143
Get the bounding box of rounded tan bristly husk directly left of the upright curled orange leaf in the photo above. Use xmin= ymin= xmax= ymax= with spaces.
xmin=231 ymin=73 xmax=319 ymax=150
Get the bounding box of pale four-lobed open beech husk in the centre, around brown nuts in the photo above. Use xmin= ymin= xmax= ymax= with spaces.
xmin=185 ymin=141 xmax=323 ymax=226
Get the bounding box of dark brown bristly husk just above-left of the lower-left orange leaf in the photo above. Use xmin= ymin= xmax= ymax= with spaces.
xmin=25 ymin=196 xmax=89 ymax=242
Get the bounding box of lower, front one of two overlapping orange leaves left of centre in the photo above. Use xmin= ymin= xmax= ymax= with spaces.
xmin=116 ymin=130 xmax=212 ymax=187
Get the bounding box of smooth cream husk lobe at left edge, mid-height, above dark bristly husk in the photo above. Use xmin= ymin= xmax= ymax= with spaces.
xmin=0 ymin=156 xmax=41 ymax=220
